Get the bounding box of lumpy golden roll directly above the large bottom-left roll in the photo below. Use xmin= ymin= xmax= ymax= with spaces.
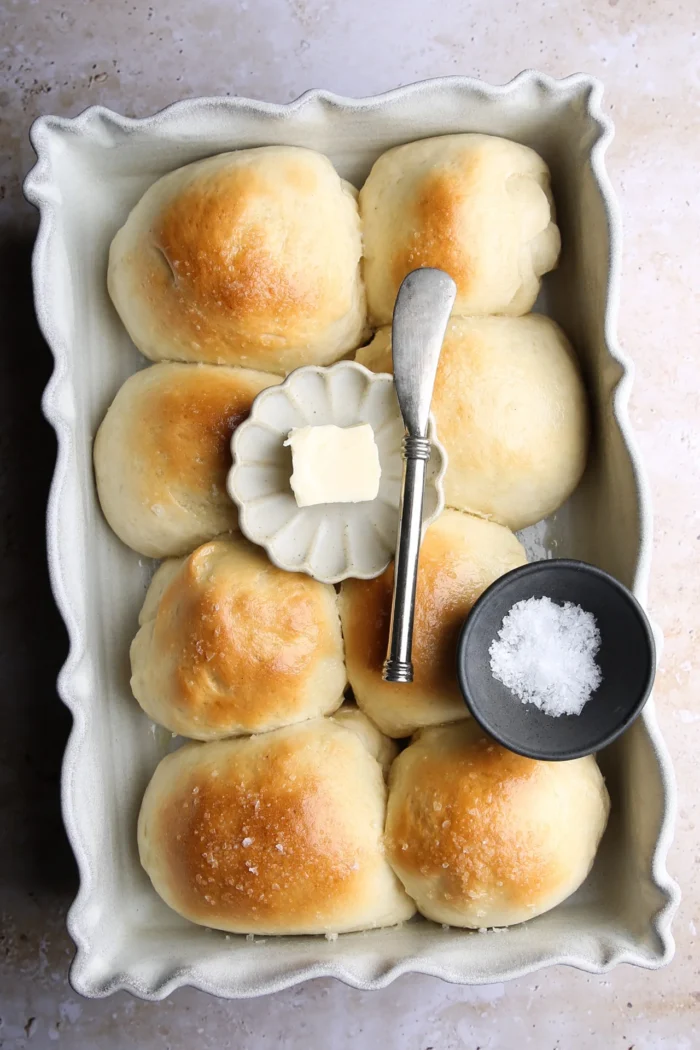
xmin=131 ymin=536 xmax=346 ymax=740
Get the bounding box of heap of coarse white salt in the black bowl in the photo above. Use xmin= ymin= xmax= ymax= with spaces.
xmin=489 ymin=597 xmax=602 ymax=717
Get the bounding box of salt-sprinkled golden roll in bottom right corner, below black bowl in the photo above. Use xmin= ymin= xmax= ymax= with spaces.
xmin=386 ymin=721 xmax=610 ymax=928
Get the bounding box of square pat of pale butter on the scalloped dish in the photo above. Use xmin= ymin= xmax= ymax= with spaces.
xmin=284 ymin=423 xmax=382 ymax=507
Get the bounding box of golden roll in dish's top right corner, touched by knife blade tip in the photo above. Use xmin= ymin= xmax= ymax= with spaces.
xmin=360 ymin=134 xmax=559 ymax=324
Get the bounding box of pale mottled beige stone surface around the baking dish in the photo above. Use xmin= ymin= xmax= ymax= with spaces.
xmin=0 ymin=0 xmax=700 ymax=1050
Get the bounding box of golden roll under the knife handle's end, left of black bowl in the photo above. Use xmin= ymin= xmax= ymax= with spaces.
xmin=340 ymin=510 xmax=526 ymax=737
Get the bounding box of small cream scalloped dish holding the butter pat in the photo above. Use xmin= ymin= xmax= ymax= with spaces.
xmin=228 ymin=361 xmax=447 ymax=584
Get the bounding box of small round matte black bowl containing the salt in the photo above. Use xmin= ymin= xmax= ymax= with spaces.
xmin=458 ymin=559 xmax=656 ymax=761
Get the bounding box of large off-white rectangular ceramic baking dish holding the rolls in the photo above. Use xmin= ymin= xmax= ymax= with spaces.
xmin=26 ymin=72 xmax=678 ymax=999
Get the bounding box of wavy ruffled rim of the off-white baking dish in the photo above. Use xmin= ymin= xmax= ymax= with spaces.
xmin=24 ymin=70 xmax=680 ymax=1000
